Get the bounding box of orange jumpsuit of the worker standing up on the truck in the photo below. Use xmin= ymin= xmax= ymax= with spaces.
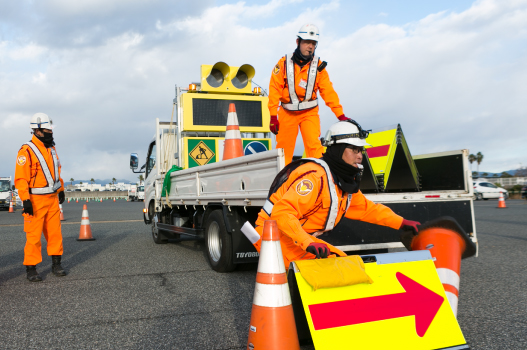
xmin=268 ymin=56 xmax=344 ymax=165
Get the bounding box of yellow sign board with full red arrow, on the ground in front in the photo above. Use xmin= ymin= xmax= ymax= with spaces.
xmin=294 ymin=251 xmax=469 ymax=350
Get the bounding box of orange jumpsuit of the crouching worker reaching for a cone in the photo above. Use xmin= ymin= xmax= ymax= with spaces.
xmin=254 ymin=162 xmax=403 ymax=268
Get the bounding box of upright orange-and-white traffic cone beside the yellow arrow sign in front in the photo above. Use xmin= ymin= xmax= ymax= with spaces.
xmin=247 ymin=220 xmax=300 ymax=350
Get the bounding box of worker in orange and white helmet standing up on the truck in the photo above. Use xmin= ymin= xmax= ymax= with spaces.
xmin=268 ymin=24 xmax=348 ymax=165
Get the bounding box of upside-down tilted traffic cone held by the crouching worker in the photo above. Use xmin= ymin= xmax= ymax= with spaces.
xmin=411 ymin=216 xmax=476 ymax=317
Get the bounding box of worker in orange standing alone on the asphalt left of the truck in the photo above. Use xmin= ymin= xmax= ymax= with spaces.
xmin=15 ymin=113 xmax=66 ymax=282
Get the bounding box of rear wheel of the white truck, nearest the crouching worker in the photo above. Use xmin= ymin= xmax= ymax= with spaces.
xmin=205 ymin=209 xmax=236 ymax=272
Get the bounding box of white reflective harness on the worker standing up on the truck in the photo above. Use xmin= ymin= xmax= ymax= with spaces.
xmin=282 ymin=53 xmax=319 ymax=111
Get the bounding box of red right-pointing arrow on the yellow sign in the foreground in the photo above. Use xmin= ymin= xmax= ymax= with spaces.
xmin=309 ymin=272 xmax=444 ymax=337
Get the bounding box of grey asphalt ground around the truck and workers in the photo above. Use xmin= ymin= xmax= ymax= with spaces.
xmin=0 ymin=200 xmax=527 ymax=350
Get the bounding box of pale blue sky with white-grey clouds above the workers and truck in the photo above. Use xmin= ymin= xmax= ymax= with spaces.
xmin=0 ymin=0 xmax=527 ymax=181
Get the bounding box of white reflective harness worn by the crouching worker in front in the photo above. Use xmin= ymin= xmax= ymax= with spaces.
xmin=263 ymin=158 xmax=352 ymax=232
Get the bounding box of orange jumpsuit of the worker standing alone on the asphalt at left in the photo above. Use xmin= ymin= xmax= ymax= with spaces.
xmin=15 ymin=136 xmax=64 ymax=265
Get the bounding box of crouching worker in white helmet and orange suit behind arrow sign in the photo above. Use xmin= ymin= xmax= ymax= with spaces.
xmin=254 ymin=120 xmax=420 ymax=268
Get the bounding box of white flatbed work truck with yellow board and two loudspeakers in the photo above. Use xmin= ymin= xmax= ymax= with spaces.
xmin=130 ymin=62 xmax=477 ymax=272
